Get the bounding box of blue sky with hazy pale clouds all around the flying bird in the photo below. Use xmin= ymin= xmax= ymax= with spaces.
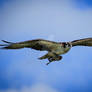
xmin=0 ymin=0 xmax=92 ymax=92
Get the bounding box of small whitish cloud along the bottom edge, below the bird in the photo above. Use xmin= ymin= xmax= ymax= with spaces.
xmin=0 ymin=84 xmax=61 ymax=92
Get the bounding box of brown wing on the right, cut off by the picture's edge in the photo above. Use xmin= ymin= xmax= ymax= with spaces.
xmin=71 ymin=38 xmax=92 ymax=46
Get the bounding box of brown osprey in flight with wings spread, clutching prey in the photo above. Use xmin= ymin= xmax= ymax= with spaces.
xmin=0 ymin=38 xmax=92 ymax=65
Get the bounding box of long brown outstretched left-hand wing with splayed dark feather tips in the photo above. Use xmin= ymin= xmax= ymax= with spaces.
xmin=0 ymin=39 xmax=57 ymax=50
